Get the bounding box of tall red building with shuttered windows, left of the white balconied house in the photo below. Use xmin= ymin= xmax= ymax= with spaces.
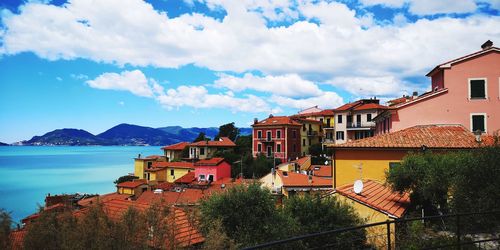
xmin=252 ymin=115 xmax=302 ymax=162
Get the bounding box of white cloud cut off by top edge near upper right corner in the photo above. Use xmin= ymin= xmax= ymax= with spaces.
xmin=409 ymin=0 xmax=477 ymax=16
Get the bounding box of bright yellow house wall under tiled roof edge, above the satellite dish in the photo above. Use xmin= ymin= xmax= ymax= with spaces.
xmin=335 ymin=149 xmax=407 ymax=187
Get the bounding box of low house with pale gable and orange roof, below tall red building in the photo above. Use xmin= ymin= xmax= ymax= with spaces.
xmin=259 ymin=170 xmax=332 ymax=197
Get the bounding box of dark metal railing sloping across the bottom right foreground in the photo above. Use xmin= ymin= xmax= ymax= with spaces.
xmin=245 ymin=211 xmax=500 ymax=250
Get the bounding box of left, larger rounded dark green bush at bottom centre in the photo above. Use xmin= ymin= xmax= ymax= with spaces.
xmin=200 ymin=183 xmax=297 ymax=246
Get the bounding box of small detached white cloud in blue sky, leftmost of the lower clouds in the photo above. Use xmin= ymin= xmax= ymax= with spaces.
xmin=86 ymin=70 xmax=156 ymax=97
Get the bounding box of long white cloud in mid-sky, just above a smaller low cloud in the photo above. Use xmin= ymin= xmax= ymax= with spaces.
xmin=215 ymin=73 xmax=321 ymax=97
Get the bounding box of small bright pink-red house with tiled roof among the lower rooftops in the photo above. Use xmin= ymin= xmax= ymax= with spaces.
xmin=194 ymin=158 xmax=231 ymax=181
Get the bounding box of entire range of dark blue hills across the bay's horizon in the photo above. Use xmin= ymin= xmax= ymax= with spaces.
xmin=14 ymin=124 xmax=252 ymax=146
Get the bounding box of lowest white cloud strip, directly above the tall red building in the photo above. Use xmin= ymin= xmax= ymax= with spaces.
xmin=270 ymin=91 xmax=344 ymax=109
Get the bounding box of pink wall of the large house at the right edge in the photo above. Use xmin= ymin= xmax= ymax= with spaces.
xmin=392 ymin=52 xmax=500 ymax=134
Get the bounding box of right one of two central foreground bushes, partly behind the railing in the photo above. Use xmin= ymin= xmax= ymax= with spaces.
xmin=283 ymin=195 xmax=366 ymax=248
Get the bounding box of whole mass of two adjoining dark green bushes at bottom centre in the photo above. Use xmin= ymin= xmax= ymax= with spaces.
xmin=200 ymin=183 xmax=366 ymax=249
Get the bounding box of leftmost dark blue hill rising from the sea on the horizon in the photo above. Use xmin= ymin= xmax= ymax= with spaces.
xmin=22 ymin=128 xmax=109 ymax=146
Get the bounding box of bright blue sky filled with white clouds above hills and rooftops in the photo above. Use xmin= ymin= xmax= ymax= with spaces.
xmin=0 ymin=0 xmax=500 ymax=143
